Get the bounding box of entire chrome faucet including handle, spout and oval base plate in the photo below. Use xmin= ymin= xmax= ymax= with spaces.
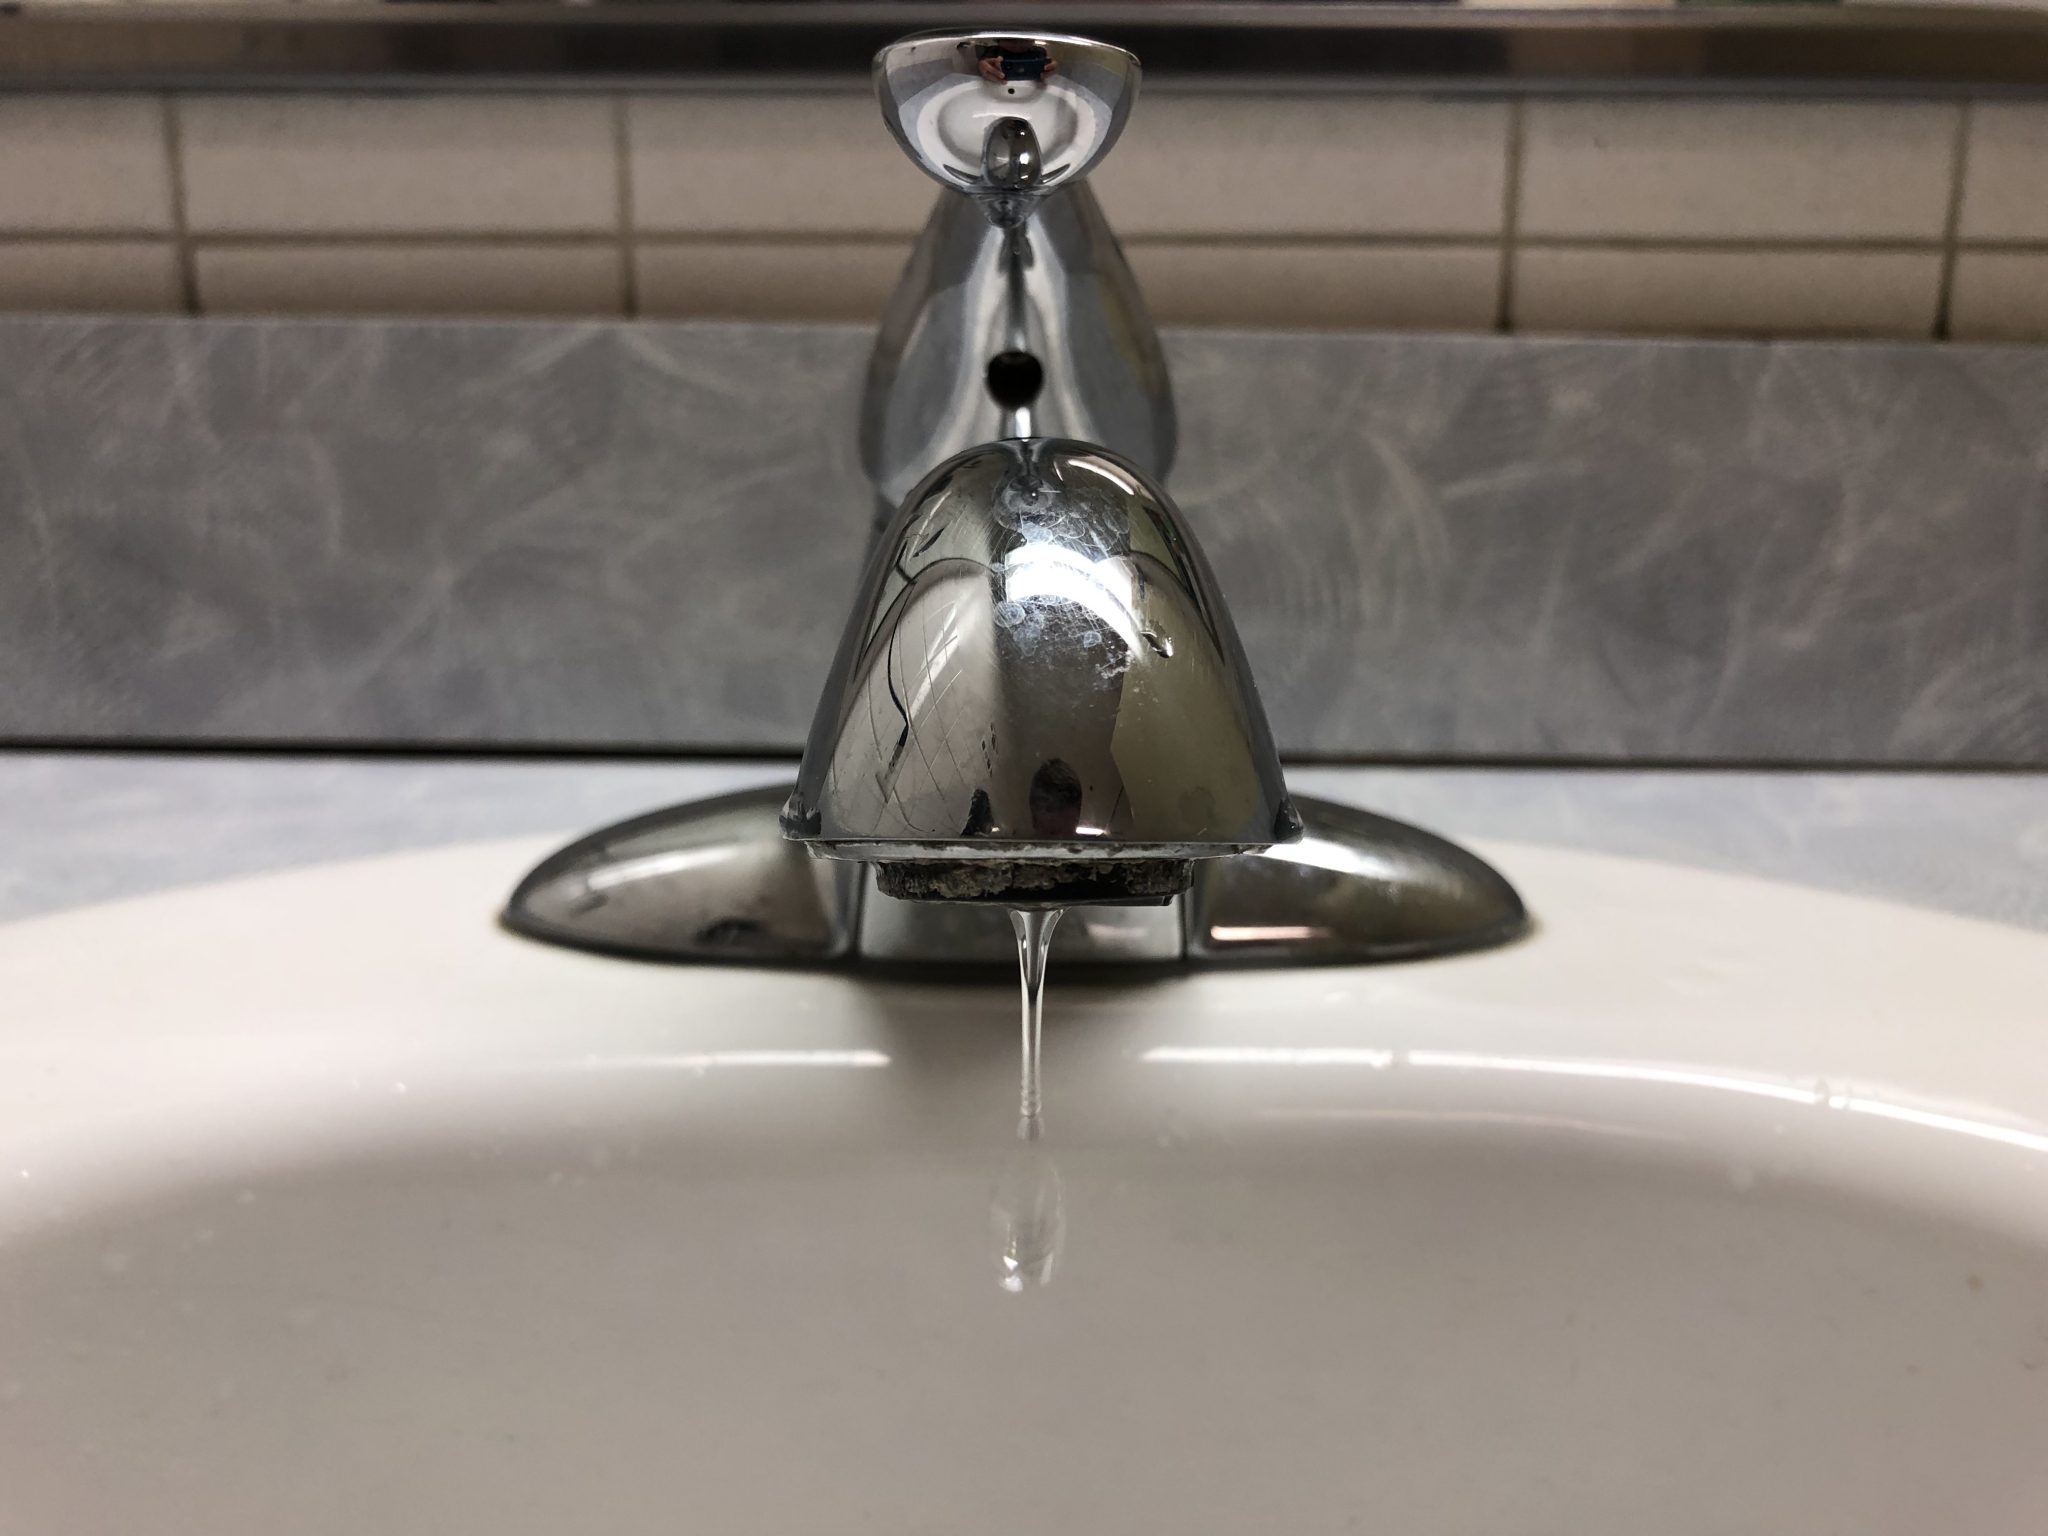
xmin=504 ymin=33 xmax=1528 ymax=965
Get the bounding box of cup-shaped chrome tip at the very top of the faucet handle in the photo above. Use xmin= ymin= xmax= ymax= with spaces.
xmin=874 ymin=33 xmax=1139 ymax=197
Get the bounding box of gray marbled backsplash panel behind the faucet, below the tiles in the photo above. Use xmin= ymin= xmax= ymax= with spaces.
xmin=0 ymin=317 xmax=2048 ymax=764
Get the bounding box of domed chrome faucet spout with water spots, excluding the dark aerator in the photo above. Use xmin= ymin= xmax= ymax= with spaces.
xmin=784 ymin=438 xmax=1298 ymax=888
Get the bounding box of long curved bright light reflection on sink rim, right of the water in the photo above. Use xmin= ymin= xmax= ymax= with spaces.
xmin=1139 ymin=1044 xmax=2048 ymax=1153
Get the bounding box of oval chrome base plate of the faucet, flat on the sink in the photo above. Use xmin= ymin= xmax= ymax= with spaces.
xmin=504 ymin=784 xmax=1528 ymax=975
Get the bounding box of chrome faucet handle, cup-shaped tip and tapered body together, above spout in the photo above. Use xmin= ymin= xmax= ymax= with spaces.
xmin=860 ymin=33 xmax=1174 ymax=510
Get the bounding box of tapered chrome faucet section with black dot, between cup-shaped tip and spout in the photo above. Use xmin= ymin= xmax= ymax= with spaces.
xmin=860 ymin=182 xmax=1176 ymax=512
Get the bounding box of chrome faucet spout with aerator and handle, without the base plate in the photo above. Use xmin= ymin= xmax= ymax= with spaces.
xmin=782 ymin=33 xmax=1300 ymax=905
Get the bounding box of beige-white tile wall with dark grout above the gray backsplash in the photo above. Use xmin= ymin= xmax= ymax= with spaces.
xmin=0 ymin=90 xmax=2048 ymax=340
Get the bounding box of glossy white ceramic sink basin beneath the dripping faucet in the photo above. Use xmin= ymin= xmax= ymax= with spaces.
xmin=0 ymin=838 xmax=2048 ymax=1536
